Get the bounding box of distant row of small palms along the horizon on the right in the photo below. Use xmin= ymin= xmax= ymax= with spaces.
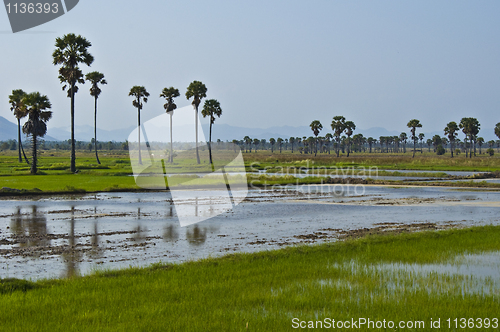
xmin=238 ymin=116 xmax=500 ymax=158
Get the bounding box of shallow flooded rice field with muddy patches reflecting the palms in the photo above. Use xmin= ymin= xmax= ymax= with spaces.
xmin=0 ymin=185 xmax=500 ymax=280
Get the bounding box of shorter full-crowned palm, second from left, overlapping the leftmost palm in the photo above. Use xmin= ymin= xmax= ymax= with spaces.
xmin=22 ymin=92 xmax=52 ymax=174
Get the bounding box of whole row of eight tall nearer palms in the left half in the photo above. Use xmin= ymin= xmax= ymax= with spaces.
xmin=9 ymin=33 xmax=222 ymax=174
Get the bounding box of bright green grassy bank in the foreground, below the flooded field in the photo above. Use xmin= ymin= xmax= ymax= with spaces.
xmin=0 ymin=226 xmax=500 ymax=331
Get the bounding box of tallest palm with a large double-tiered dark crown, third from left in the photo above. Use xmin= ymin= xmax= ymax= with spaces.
xmin=52 ymin=33 xmax=94 ymax=173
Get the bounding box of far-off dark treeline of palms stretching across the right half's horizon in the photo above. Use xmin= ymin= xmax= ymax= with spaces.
xmin=233 ymin=116 xmax=500 ymax=157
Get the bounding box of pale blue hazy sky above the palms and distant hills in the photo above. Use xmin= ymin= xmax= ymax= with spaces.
xmin=0 ymin=0 xmax=500 ymax=132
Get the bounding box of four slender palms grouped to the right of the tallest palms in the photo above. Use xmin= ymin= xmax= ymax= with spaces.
xmin=128 ymin=81 xmax=222 ymax=167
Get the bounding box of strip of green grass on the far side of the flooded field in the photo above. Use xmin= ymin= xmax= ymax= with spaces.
xmin=0 ymin=150 xmax=500 ymax=195
